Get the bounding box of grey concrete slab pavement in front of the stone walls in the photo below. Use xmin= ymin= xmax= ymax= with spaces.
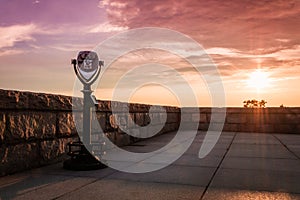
xmin=0 ymin=132 xmax=300 ymax=200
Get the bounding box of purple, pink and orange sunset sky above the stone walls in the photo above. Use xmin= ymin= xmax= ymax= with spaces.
xmin=0 ymin=0 xmax=300 ymax=107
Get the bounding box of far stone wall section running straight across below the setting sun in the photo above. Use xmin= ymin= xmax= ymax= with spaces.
xmin=195 ymin=107 xmax=300 ymax=134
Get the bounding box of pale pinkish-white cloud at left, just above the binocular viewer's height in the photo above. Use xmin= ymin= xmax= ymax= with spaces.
xmin=0 ymin=23 xmax=113 ymax=56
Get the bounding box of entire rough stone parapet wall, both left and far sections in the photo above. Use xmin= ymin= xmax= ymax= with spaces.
xmin=0 ymin=90 xmax=300 ymax=175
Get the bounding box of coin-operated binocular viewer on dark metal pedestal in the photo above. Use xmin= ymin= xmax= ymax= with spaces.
xmin=64 ymin=51 xmax=106 ymax=170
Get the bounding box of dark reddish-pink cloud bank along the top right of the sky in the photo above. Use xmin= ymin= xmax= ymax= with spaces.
xmin=104 ymin=0 xmax=300 ymax=51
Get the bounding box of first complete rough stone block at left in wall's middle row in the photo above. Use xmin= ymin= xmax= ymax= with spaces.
xmin=5 ymin=112 xmax=56 ymax=143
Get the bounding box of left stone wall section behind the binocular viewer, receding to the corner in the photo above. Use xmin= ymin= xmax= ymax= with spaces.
xmin=0 ymin=90 xmax=179 ymax=176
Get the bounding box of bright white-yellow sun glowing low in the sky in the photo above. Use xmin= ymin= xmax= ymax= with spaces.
xmin=247 ymin=69 xmax=270 ymax=90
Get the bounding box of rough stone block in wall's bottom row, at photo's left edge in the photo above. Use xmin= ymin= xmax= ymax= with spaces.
xmin=0 ymin=143 xmax=40 ymax=176
